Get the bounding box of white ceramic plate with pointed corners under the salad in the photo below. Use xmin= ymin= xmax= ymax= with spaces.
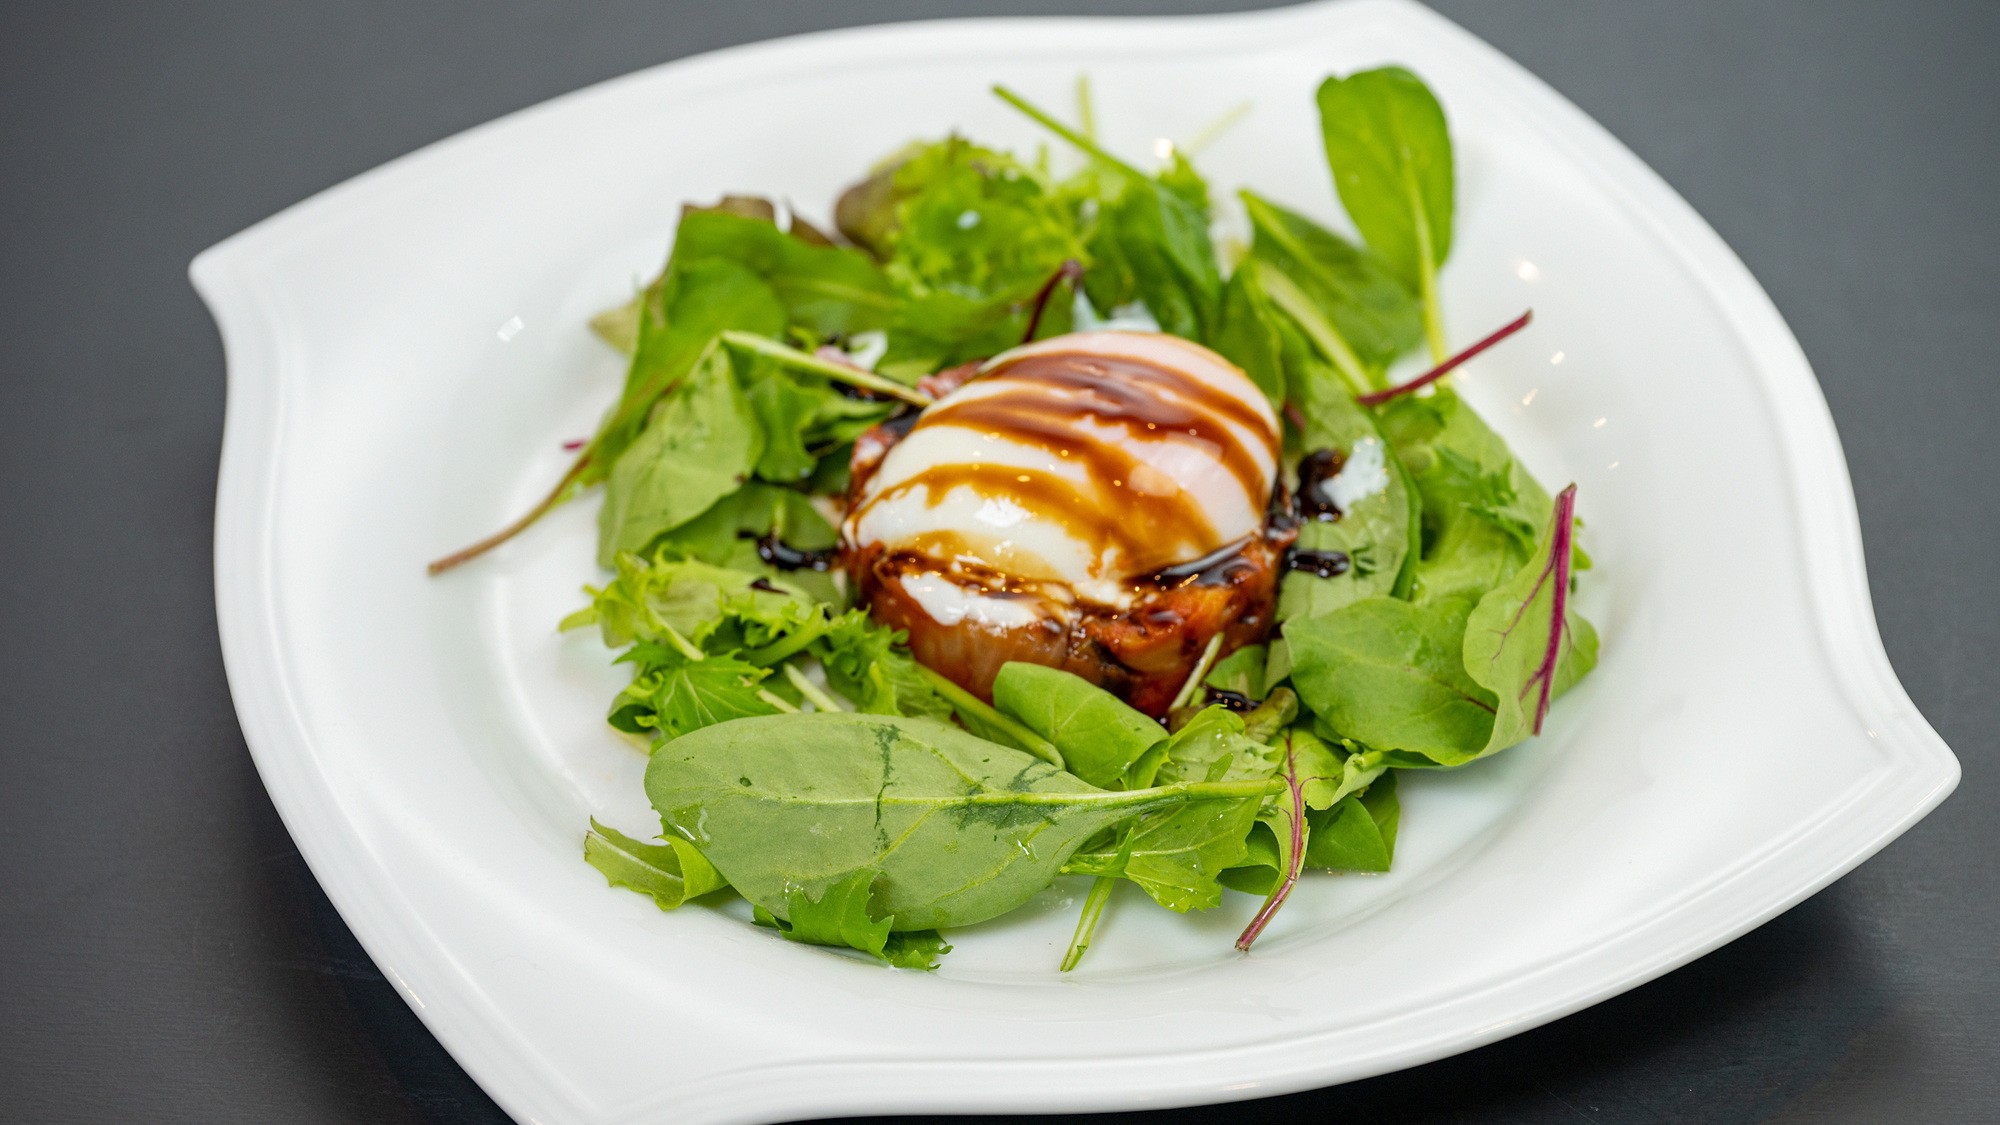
xmin=192 ymin=0 xmax=1958 ymax=1123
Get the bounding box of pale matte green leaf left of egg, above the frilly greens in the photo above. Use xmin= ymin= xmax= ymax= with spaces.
xmin=598 ymin=336 xmax=764 ymax=569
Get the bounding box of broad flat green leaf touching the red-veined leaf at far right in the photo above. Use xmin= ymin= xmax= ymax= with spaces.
xmin=1284 ymin=597 xmax=1494 ymax=765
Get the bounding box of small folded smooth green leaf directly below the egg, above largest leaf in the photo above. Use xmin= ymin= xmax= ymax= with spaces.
xmin=994 ymin=661 xmax=1166 ymax=789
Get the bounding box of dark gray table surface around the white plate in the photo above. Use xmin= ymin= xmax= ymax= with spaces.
xmin=0 ymin=0 xmax=2000 ymax=1123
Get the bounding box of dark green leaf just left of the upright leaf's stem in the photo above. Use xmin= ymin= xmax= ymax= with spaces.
xmin=1242 ymin=192 xmax=1424 ymax=370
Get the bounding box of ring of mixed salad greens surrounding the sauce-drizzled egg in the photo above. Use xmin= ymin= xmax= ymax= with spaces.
xmin=446 ymin=66 xmax=1598 ymax=969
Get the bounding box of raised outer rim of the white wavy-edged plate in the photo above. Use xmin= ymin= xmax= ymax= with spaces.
xmin=190 ymin=0 xmax=1960 ymax=1121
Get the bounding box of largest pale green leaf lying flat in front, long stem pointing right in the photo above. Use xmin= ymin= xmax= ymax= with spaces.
xmin=646 ymin=713 xmax=1268 ymax=929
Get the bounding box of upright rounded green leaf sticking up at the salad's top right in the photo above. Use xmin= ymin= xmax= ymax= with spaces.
xmin=1318 ymin=66 xmax=1454 ymax=360
